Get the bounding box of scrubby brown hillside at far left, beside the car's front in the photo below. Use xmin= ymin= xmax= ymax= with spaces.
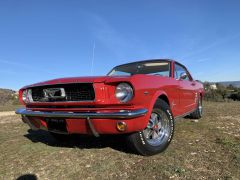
xmin=0 ymin=88 xmax=19 ymax=106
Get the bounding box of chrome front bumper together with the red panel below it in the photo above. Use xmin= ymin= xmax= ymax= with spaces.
xmin=16 ymin=108 xmax=148 ymax=137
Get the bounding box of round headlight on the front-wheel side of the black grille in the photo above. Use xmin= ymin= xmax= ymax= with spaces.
xmin=115 ymin=83 xmax=133 ymax=102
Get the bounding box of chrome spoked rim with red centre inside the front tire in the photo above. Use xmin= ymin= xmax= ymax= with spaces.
xmin=143 ymin=112 xmax=170 ymax=146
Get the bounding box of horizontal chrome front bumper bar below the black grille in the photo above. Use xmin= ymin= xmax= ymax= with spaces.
xmin=16 ymin=108 xmax=148 ymax=119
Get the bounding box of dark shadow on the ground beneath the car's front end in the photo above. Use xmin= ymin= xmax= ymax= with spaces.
xmin=24 ymin=129 xmax=135 ymax=154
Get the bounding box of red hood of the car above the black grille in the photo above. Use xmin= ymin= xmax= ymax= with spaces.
xmin=23 ymin=76 xmax=131 ymax=89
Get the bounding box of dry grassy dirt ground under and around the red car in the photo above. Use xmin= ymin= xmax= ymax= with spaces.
xmin=0 ymin=102 xmax=240 ymax=179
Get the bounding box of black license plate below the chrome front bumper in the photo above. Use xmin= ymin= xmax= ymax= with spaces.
xmin=45 ymin=118 xmax=67 ymax=133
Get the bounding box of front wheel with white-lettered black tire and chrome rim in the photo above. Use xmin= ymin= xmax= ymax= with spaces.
xmin=127 ymin=99 xmax=174 ymax=156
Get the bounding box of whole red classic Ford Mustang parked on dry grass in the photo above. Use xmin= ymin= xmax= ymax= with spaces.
xmin=16 ymin=59 xmax=204 ymax=155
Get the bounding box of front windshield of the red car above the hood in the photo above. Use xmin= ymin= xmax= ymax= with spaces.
xmin=108 ymin=61 xmax=170 ymax=77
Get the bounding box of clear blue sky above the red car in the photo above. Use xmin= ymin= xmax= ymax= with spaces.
xmin=0 ymin=0 xmax=240 ymax=90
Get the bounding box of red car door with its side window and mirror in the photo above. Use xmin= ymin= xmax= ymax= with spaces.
xmin=174 ymin=63 xmax=196 ymax=114
